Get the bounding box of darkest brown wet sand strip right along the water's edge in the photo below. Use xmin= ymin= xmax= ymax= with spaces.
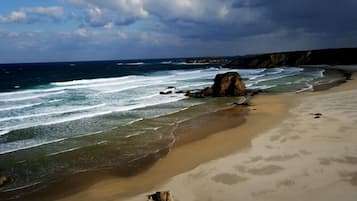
xmin=0 ymin=98 xmax=247 ymax=200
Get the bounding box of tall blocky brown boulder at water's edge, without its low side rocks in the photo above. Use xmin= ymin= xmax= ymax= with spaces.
xmin=212 ymin=72 xmax=246 ymax=97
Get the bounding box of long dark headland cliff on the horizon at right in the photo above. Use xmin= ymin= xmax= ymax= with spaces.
xmin=227 ymin=48 xmax=357 ymax=68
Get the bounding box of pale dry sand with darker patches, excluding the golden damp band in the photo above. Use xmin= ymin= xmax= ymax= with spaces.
xmin=124 ymin=75 xmax=357 ymax=201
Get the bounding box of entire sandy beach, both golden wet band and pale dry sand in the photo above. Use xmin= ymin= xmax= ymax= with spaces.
xmin=11 ymin=71 xmax=357 ymax=201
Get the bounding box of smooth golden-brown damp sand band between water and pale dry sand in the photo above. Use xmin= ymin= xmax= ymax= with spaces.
xmin=21 ymin=91 xmax=295 ymax=201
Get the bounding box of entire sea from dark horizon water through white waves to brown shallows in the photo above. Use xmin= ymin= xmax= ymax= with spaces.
xmin=0 ymin=59 xmax=326 ymax=196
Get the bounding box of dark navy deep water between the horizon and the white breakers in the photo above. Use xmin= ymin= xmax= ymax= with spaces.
xmin=0 ymin=59 xmax=206 ymax=91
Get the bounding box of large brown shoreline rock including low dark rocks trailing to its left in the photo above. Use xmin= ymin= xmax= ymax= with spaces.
xmin=186 ymin=72 xmax=246 ymax=98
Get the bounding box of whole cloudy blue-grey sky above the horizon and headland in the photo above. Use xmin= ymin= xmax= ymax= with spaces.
xmin=0 ymin=0 xmax=357 ymax=63
